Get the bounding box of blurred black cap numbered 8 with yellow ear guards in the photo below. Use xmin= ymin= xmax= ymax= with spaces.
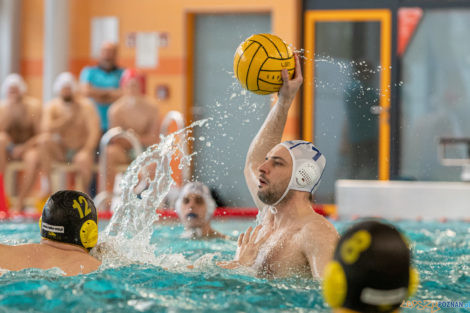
xmin=323 ymin=220 xmax=418 ymax=313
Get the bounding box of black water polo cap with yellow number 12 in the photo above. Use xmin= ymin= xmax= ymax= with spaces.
xmin=39 ymin=190 xmax=98 ymax=249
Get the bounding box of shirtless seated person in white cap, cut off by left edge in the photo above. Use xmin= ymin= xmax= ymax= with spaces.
xmin=0 ymin=74 xmax=42 ymax=213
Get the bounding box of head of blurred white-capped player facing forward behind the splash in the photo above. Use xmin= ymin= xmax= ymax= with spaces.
xmin=175 ymin=182 xmax=216 ymax=235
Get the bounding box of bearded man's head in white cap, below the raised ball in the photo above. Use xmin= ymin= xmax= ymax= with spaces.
xmin=258 ymin=140 xmax=326 ymax=206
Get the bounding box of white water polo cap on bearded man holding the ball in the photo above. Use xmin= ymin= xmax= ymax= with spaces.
xmin=274 ymin=140 xmax=326 ymax=205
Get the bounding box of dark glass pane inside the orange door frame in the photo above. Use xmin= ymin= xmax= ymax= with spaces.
xmin=312 ymin=21 xmax=380 ymax=203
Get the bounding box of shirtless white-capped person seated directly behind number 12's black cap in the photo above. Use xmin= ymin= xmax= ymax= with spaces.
xmin=39 ymin=73 xmax=100 ymax=192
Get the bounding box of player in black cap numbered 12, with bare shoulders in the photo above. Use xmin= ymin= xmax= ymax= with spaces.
xmin=0 ymin=190 xmax=101 ymax=276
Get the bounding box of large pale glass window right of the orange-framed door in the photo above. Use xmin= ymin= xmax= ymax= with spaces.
xmin=400 ymin=9 xmax=470 ymax=181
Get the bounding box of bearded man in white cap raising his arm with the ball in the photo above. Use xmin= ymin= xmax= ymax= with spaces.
xmin=219 ymin=55 xmax=338 ymax=278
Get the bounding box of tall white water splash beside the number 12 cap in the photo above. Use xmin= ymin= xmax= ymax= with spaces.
xmin=92 ymin=118 xmax=210 ymax=266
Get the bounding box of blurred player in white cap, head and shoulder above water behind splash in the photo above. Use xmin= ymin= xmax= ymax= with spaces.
xmin=175 ymin=182 xmax=226 ymax=239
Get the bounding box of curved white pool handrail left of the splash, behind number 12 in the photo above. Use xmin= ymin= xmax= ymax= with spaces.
xmin=94 ymin=127 xmax=143 ymax=208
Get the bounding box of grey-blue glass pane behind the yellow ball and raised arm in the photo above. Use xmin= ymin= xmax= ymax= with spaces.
xmin=193 ymin=14 xmax=271 ymax=207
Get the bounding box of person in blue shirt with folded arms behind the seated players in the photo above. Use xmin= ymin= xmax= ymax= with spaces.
xmin=80 ymin=42 xmax=124 ymax=132
